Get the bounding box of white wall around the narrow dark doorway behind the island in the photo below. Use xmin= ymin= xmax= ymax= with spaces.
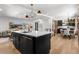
xmin=32 ymin=16 xmax=51 ymax=31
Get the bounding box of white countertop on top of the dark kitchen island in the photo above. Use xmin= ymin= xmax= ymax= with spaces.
xmin=14 ymin=31 xmax=51 ymax=37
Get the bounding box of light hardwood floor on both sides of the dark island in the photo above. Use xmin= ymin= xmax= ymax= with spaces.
xmin=0 ymin=35 xmax=79 ymax=54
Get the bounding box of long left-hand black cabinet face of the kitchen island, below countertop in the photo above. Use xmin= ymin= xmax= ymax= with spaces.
xmin=12 ymin=33 xmax=33 ymax=54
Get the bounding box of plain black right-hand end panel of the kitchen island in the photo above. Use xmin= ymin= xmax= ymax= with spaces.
xmin=35 ymin=34 xmax=50 ymax=54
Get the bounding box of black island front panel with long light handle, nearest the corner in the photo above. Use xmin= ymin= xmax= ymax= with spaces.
xmin=20 ymin=36 xmax=33 ymax=54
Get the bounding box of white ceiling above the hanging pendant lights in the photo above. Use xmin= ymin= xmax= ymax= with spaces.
xmin=0 ymin=4 xmax=79 ymax=17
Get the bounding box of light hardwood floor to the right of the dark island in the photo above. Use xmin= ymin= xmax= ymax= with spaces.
xmin=50 ymin=35 xmax=79 ymax=54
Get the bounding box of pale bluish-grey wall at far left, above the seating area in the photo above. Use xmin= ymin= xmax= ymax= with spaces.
xmin=0 ymin=17 xmax=31 ymax=32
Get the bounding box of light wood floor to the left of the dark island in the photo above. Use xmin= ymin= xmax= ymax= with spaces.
xmin=0 ymin=38 xmax=20 ymax=54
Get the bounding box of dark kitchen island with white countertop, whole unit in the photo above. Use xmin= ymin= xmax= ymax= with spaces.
xmin=12 ymin=31 xmax=51 ymax=54
